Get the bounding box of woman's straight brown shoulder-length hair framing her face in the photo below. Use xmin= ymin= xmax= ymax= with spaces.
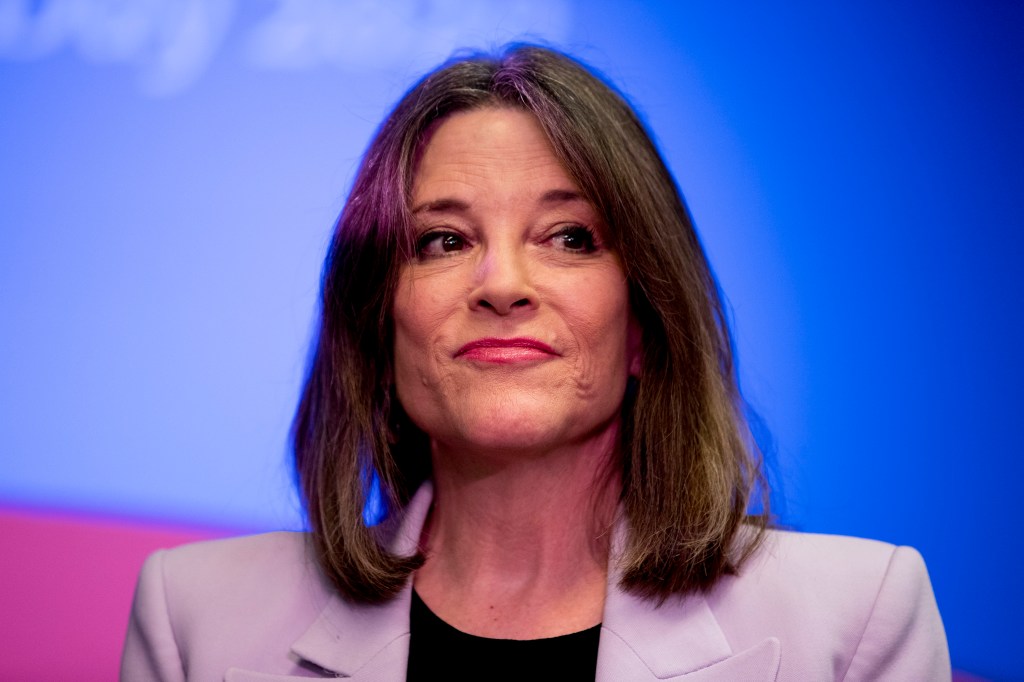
xmin=293 ymin=45 xmax=768 ymax=602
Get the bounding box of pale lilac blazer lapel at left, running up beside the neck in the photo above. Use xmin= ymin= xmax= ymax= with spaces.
xmin=292 ymin=482 xmax=432 ymax=682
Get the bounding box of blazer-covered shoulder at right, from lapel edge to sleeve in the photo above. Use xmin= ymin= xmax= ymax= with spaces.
xmin=708 ymin=530 xmax=948 ymax=679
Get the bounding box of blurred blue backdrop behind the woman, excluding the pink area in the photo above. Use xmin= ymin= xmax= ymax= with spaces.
xmin=0 ymin=0 xmax=1024 ymax=679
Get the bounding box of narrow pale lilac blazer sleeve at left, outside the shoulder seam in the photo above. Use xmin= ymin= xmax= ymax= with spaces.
xmin=121 ymin=550 xmax=185 ymax=682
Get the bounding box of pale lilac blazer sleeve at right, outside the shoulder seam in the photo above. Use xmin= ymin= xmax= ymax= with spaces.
xmin=844 ymin=547 xmax=952 ymax=682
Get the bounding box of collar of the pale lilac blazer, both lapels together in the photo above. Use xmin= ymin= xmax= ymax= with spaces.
xmin=284 ymin=482 xmax=779 ymax=682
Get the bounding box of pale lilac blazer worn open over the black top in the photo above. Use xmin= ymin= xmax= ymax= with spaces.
xmin=121 ymin=485 xmax=950 ymax=682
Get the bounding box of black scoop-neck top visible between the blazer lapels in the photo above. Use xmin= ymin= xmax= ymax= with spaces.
xmin=406 ymin=590 xmax=601 ymax=682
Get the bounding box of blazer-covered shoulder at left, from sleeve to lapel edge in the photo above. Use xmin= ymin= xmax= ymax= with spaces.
xmin=122 ymin=532 xmax=333 ymax=679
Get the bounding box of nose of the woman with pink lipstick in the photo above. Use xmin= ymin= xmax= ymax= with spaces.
xmin=469 ymin=245 xmax=538 ymax=315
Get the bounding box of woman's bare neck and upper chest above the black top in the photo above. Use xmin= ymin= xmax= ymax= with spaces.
xmin=415 ymin=423 xmax=620 ymax=639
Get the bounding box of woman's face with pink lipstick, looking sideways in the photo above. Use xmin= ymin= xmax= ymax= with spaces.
xmin=393 ymin=108 xmax=639 ymax=455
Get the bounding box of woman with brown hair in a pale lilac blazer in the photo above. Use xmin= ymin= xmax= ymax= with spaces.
xmin=123 ymin=46 xmax=949 ymax=680
